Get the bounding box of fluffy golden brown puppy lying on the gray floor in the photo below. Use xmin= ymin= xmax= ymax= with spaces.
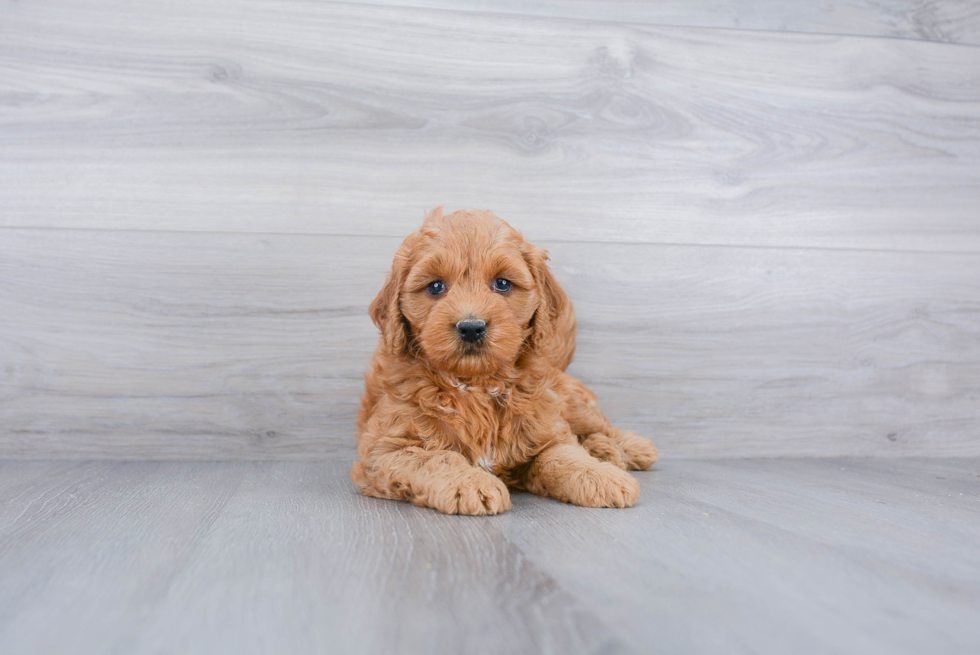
xmin=350 ymin=207 xmax=657 ymax=514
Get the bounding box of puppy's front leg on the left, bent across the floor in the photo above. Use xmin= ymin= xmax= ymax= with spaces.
xmin=350 ymin=446 xmax=510 ymax=516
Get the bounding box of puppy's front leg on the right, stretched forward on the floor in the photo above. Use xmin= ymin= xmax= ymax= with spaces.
xmin=523 ymin=442 xmax=640 ymax=507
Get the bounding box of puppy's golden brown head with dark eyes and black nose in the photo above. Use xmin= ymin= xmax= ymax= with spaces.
xmin=370 ymin=207 xmax=568 ymax=377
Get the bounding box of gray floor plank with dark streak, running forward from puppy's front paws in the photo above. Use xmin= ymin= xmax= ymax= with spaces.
xmin=134 ymin=463 xmax=625 ymax=655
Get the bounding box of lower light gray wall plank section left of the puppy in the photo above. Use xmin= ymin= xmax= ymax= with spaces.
xmin=0 ymin=231 xmax=378 ymax=459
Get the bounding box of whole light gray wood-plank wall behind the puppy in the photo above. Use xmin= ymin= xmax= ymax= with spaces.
xmin=0 ymin=0 xmax=980 ymax=458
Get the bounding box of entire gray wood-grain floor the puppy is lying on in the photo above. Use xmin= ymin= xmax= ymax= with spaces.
xmin=0 ymin=459 xmax=980 ymax=655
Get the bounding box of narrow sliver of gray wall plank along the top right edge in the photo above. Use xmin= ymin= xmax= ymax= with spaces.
xmin=326 ymin=0 xmax=980 ymax=45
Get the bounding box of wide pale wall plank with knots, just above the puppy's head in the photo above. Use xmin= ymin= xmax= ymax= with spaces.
xmin=0 ymin=0 xmax=980 ymax=252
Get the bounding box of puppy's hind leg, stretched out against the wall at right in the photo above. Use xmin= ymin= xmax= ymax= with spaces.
xmin=562 ymin=375 xmax=657 ymax=471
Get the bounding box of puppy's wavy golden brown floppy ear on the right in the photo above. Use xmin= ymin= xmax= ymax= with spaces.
xmin=522 ymin=244 xmax=575 ymax=370
